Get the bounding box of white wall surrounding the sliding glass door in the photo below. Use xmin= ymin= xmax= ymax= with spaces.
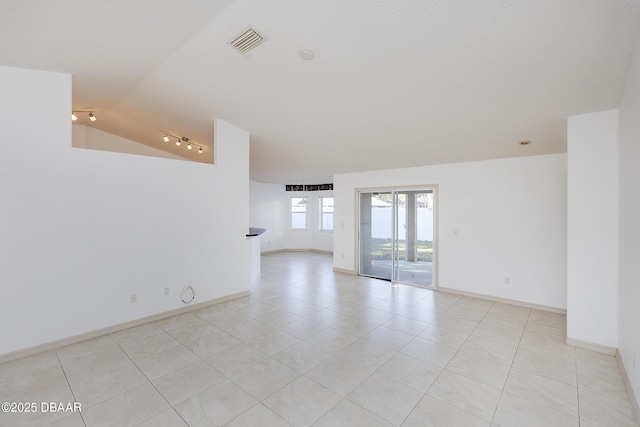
xmin=333 ymin=154 xmax=567 ymax=309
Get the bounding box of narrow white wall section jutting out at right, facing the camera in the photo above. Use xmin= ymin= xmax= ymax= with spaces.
xmin=567 ymin=110 xmax=618 ymax=348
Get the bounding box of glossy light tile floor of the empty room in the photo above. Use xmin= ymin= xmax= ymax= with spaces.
xmin=0 ymin=253 xmax=638 ymax=427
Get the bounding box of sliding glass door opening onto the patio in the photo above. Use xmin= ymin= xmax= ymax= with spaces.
xmin=359 ymin=189 xmax=434 ymax=287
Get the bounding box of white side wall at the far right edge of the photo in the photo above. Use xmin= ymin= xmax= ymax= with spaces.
xmin=618 ymin=33 xmax=640 ymax=404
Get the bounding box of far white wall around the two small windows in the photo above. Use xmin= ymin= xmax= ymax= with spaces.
xmin=250 ymin=181 xmax=333 ymax=252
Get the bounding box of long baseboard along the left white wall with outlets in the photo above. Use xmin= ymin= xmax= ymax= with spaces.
xmin=0 ymin=291 xmax=249 ymax=363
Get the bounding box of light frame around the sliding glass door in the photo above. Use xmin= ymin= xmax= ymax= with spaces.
xmin=354 ymin=184 xmax=440 ymax=290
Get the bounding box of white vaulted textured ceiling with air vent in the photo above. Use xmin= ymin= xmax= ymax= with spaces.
xmin=0 ymin=0 xmax=640 ymax=183
